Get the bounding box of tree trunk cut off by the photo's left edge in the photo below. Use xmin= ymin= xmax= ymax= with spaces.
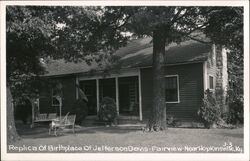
xmin=6 ymin=87 xmax=20 ymax=144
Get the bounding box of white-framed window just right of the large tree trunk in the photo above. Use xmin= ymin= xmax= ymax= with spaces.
xmin=165 ymin=75 xmax=179 ymax=103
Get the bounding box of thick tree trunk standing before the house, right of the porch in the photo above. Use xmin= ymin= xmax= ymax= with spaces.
xmin=148 ymin=27 xmax=167 ymax=131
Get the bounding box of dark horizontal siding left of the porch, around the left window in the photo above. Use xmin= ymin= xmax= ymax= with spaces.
xmin=39 ymin=76 xmax=76 ymax=114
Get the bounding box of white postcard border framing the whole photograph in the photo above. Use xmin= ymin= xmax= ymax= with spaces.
xmin=0 ymin=0 xmax=249 ymax=161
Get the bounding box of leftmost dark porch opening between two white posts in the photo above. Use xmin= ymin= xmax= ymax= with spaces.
xmin=79 ymin=80 xmax=97 ymax=115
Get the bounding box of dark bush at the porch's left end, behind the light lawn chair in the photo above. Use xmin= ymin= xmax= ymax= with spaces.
xmin=70 ymin=99 xmax=88 ymax=125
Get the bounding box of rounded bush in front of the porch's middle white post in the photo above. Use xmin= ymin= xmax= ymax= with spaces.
xmin=98 ymin=97 xmax=117 ymax=123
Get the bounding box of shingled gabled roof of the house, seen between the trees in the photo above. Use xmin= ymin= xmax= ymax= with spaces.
xmin=45 ymin=37 xmax=211 ymax=76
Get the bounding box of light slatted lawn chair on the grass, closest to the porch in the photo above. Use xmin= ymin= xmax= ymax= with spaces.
xmin=49 ymin=112 xmax=76 ymax=136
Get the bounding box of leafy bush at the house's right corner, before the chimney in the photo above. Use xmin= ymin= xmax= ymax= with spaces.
xmin=198 ymin=90 xmax=221 ymax=128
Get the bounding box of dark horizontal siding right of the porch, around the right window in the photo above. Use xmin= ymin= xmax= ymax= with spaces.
xmin=141 ymin=63 xmax=203 ymax=119
